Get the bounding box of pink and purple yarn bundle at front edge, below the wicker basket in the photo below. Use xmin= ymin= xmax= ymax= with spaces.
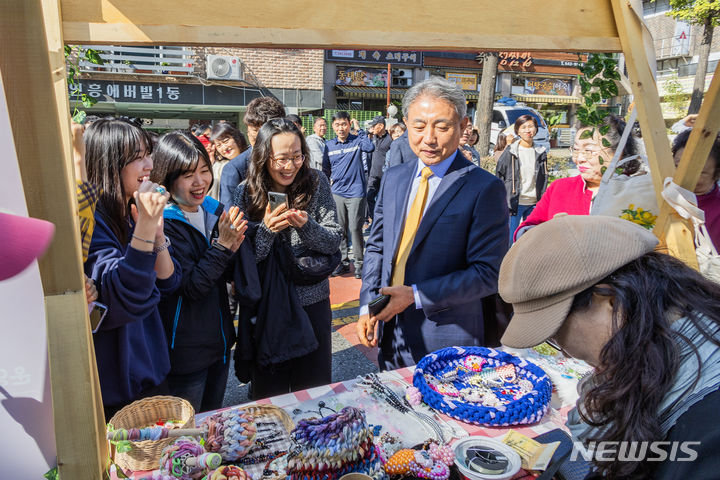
xmin=160 ymin=437 xmax=222 ymax=480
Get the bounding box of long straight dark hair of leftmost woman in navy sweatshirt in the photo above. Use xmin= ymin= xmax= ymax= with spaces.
xmin=84 ymin=117 xmax=153 ymax=243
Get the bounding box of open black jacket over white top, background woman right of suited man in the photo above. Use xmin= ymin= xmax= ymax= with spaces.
xmin=495 ymin=141 xmax=547 ymax=215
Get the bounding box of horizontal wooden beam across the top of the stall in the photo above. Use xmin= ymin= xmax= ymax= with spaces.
xmin=62 ymin=0 xmax=620 ymax=52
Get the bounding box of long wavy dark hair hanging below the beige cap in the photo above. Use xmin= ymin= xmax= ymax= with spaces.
xmin=570 ymin=252 xmax=720 ymax=479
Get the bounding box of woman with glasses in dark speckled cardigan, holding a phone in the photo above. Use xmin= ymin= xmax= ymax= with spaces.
xmin=234 ymin=119 xmax=341 ymax=398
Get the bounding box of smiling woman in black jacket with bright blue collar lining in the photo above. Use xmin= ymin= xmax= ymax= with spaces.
xmin=152 ymin=131 xmax=247 ymax=411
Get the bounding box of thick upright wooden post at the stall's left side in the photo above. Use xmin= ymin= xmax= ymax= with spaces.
xmin=0 ymin=0 xmax=108 ymax=479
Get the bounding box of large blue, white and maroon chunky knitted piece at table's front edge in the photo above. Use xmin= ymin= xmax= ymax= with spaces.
xmin=287 ymin=407 xmax=385 ymax=480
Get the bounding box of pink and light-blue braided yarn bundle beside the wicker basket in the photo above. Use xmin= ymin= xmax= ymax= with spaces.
xmin=201 ymin=409 xmax=257 ymax=462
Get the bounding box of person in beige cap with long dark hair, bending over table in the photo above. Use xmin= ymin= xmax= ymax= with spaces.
xmin=499 ymin=216 xmax=720 ymax=479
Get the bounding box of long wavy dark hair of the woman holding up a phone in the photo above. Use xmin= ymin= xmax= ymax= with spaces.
xmin=246 ymin=118 xmax=318 ymax=221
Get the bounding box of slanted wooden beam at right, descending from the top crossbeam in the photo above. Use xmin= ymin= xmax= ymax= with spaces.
xmin=611 ymin=0 xmax=697 ymax=268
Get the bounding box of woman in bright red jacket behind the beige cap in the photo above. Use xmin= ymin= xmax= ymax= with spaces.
xmin=510 ymin=115 xmax=640 ymax=240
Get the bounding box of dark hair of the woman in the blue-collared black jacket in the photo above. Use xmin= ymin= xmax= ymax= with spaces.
xmin=150 ymin=130 xmax=215 ymax=199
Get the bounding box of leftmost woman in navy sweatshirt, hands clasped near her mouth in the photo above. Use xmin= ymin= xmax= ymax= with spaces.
xmin=84 ymin=118 xmax=180 ymax=418
